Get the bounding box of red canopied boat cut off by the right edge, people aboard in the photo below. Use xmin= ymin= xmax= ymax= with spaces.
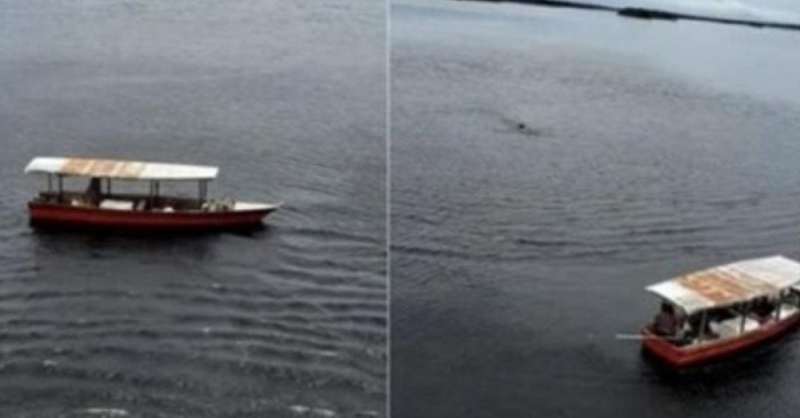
xmin=640 ymin=255 xmax=800 ymax=369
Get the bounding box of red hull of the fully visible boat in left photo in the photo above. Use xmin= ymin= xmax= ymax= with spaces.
xmin=28 ymin=202 xmax=275 ymax=232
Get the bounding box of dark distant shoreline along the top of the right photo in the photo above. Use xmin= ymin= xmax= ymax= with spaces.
xmin=456 ymin=0 xmax=800 ymax=31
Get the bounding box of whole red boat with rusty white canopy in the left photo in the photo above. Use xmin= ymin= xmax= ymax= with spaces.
xmin=25 ymin=157 xmax=281 ymax=232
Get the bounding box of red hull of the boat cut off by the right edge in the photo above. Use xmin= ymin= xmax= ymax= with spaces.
xmin=641 ymin=311 xmax=800 ymax=368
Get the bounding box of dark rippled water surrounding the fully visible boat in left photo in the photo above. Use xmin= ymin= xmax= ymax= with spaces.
xmin=0 ymin=0 xmax=386 ymax=417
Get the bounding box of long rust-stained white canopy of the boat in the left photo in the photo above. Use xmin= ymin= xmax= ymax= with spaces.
xmin=25 ymin=157 xmax=219 ymax=181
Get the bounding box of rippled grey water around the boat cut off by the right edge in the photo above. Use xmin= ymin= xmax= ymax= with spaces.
xmin=391 ymin=0 xmax=800 ymax=418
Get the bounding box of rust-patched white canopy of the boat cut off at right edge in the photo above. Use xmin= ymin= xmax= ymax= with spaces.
xmin=646 ymin=256 xmax=800 ymax=314
